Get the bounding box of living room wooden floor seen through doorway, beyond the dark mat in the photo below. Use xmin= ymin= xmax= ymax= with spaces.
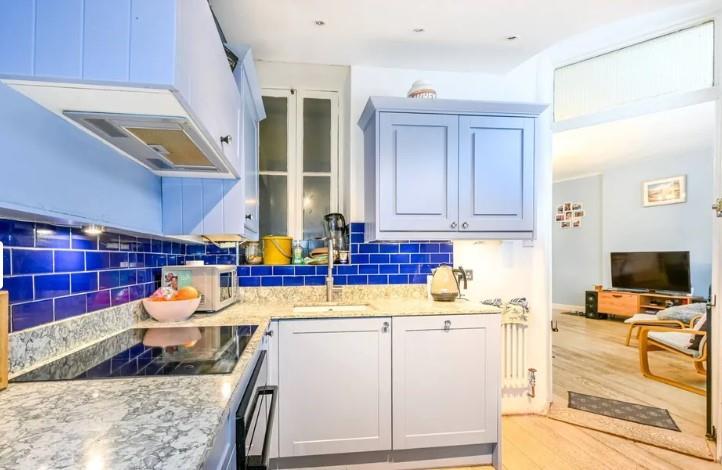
xmin=552 ymin=311 xmax=706 ymax=437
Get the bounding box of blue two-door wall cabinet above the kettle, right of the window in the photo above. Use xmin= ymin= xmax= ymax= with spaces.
xmin=359 ymin=97 xmax=546 ymax=241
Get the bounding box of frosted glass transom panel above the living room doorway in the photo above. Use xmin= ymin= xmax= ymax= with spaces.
xmin=554 ymin=22 xmax=714 ymax=121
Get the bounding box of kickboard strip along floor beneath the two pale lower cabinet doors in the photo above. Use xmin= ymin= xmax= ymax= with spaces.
xmin=269 ymin=444 xmax=501 ymax=470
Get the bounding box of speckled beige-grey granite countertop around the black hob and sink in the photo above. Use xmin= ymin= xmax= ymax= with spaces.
xmin=0 ymin=299 xmax=500 ymax=470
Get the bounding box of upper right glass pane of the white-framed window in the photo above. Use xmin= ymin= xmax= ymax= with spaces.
xmin=303 ymin=98 xmax=331 ymax=173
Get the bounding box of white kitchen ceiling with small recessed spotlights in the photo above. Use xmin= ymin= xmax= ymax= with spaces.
xmin=211 ymin=0 xmax=685 ymax=73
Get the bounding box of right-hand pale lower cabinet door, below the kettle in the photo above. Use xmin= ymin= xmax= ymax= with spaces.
xmin=393 ymin=315 xmax=500 ymax=449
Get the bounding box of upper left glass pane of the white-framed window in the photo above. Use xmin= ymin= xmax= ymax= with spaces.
xmin=259 ymin=96 xmax=288 ymax=171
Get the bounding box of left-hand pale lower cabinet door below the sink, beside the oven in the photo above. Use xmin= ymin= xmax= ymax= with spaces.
xmin=278 ymin=318 xmax=391 ymax=457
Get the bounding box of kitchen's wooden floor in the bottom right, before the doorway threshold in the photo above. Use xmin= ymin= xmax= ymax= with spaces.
xmin=438 ymin=416 xmax=720 ymax=470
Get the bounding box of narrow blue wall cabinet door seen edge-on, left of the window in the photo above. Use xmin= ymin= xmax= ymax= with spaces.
xmin=242 ymin=72 xmax=259 ymax=240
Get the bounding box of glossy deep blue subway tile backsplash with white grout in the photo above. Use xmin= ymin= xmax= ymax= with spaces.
xmin=0 ymin=219 xmax=453 ymax=331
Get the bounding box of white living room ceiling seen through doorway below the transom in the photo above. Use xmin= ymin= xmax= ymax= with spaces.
xmin=553 ymin=102 xmax=715 ymax=181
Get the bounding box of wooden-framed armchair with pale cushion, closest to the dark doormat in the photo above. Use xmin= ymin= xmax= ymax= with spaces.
xmin=639 ymin=318 xmax=707 ymax=396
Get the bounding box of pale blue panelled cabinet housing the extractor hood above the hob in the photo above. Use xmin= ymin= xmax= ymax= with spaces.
xmin=0 ymin=0 xmax=243 ymax=179
